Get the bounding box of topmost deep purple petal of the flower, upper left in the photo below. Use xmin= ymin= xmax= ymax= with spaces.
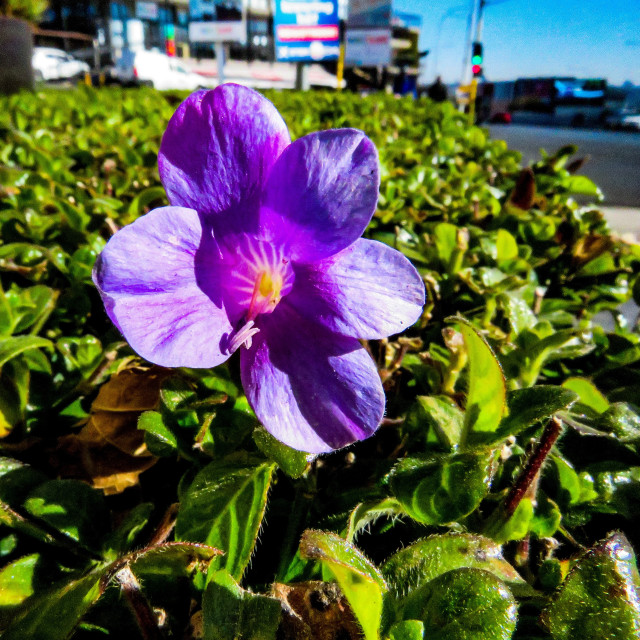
xmin=158 ymin=84 xmax=291 ymax=230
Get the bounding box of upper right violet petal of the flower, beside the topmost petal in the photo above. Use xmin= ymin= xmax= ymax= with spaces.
xmin=260 ymin=129 xmax=380 ymax=262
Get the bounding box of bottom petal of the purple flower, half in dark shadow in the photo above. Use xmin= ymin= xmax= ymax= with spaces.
xmin=240 ymin=301 xmax=384 ymax=453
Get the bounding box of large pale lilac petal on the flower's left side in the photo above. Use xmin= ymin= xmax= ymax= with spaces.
xmin=93 ymin=207 xmax=232 ymax=367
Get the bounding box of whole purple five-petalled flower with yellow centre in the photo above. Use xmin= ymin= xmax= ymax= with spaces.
xmin=93 ymin=84 xmax=424 ymax=453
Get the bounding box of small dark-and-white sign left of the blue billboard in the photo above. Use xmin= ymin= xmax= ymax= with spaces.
xmin=189 ymin=0 xmax=247 ymax=42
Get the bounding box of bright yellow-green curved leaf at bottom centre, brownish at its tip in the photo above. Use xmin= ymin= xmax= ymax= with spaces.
xmin=300 ymin=530 xmax=387 ymax=640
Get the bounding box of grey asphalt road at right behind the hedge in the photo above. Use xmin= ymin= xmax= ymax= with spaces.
xmin=489 ymin=124 xmax=640 ymax=207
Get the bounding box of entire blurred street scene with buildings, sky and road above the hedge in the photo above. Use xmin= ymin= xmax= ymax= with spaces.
xmin=0 ymin=0 xmax=640 ymax=210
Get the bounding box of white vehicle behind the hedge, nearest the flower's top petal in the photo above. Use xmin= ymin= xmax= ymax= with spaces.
xmin=114 ymin=49 xmax=210 ymax=91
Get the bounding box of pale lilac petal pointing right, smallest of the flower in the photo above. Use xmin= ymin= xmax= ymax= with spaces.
xmin=287 ymin=238 xmax=424 ymax=340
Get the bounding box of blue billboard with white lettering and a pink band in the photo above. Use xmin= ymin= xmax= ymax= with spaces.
xmin=274 ymin=0 xmax=340 ymax=62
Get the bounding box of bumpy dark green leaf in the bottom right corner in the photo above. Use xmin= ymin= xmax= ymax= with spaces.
xmin=545 ymin=533 xmax=640 ymax=640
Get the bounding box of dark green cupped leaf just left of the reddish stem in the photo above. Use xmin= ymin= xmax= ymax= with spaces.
xmin=390 ymin=452 xmax=495 ymax=524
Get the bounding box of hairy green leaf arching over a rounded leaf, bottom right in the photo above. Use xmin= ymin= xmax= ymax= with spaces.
xmin=381 ymin=533 xmax=530 ymax=596
